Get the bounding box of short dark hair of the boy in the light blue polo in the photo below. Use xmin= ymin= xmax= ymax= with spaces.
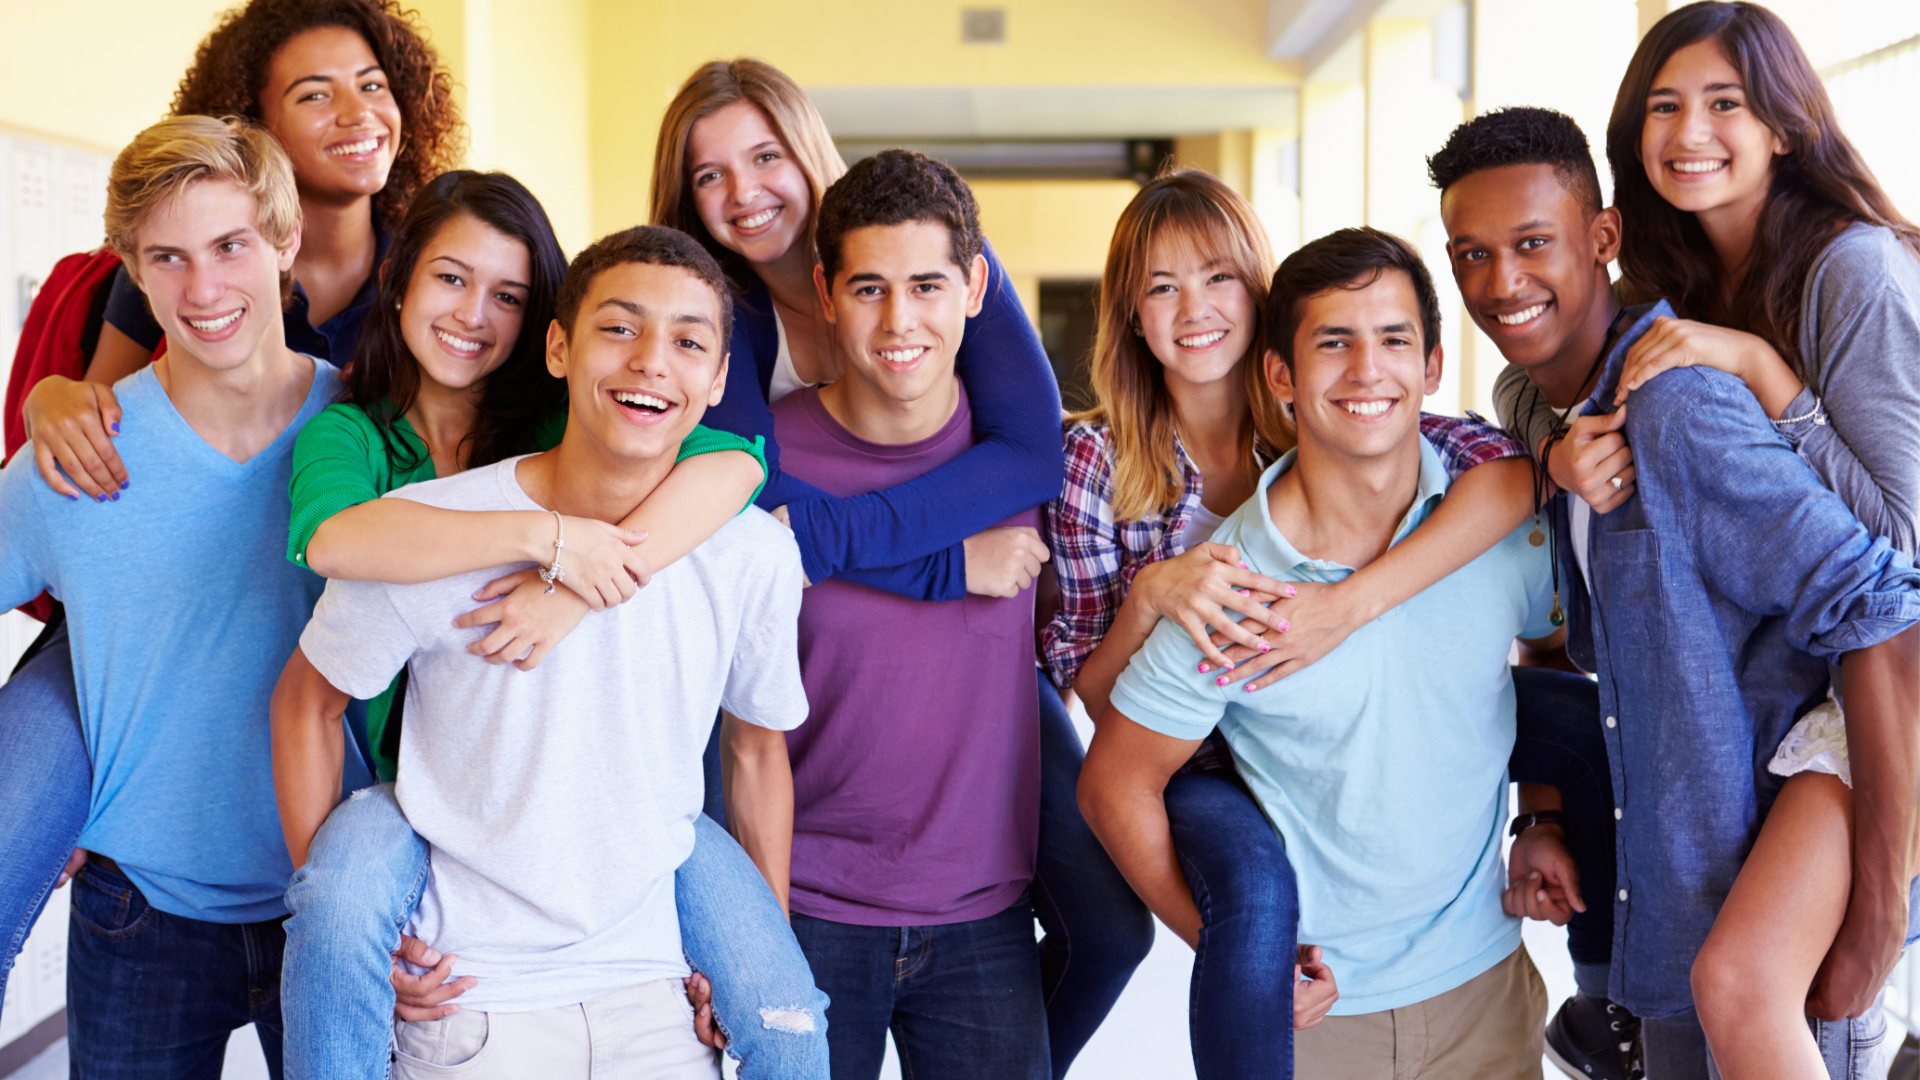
xmin=1265 ymin=227 xmax=1440 ymax=369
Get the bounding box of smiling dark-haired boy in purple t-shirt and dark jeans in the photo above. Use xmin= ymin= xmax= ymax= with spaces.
xmin=774 ymin=150 xmax=1050 ymax=1080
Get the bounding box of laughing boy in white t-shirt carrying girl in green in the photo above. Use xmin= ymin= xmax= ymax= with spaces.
xmin=275 ymin=227 xmax=806 ymax=1078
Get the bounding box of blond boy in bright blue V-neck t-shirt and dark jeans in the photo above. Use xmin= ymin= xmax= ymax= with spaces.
xmin=0 ymin=117 xmax=340 ymax=1076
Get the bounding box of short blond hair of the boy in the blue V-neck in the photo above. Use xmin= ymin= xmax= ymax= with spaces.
xmin=106 ymin=115 xmax=300 ymax=259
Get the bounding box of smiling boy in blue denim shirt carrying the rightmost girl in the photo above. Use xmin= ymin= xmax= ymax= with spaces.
xmin=1428 ymin=110 xmax=1920 ymax=1078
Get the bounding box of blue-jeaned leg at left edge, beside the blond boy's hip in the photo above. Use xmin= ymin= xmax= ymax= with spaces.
xmin=0 ymin=626 xmax=92 ymax=997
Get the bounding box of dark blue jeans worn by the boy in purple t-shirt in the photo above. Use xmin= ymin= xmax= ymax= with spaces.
xmin=793 ymin=896 xmax=1052 ymax=1080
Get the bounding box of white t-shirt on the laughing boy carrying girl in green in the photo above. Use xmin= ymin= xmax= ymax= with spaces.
xmin=300 ymin=457 xmax=806 ymax=1013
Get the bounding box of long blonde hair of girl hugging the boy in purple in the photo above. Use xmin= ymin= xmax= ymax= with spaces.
xmin=651 ymin=56 xmax=847 ymax=282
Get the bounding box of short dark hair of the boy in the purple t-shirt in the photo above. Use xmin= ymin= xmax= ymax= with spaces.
xmin=814 ymin=150 xmax=985 ymax=288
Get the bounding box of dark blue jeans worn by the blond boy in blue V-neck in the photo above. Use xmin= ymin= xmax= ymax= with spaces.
xmin=67 ymin=863 xmax=286 ymax=1080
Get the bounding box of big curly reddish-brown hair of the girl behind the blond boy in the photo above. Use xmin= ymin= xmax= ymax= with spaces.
xmin=173 ymin=0 xmax=463 ymax=229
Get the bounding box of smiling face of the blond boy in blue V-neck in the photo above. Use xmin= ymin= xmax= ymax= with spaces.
xmin=127 ymin=179 xmax=300 ymax=371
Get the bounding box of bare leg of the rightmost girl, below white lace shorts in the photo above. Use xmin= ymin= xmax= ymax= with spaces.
xmin=1693 ymin=773 xmax=1853 ymax=1080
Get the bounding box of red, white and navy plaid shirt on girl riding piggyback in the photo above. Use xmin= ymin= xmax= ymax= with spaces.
xmin=1041 ymin=413 xmax=1526 ymax=688
